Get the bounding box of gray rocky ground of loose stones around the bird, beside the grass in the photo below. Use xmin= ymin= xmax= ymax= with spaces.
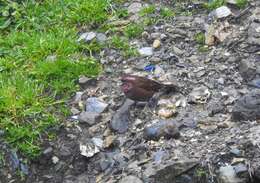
xmin=0 ymin=0 xmax=260 ymax=183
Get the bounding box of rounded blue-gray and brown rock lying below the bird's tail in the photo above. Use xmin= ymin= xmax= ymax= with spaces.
xmin=144 ymin=120 xmax=180 ymax=140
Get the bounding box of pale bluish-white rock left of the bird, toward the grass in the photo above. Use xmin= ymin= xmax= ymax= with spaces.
xmin=86 ymin=97 xmax=108 ymax=113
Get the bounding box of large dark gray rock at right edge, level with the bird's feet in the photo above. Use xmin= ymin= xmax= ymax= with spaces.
xmin=232 ymin=90 xmax=260 ymax=121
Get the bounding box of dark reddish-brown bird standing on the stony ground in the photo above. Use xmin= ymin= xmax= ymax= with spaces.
xmin=121 ymin=75 xmax=179 ymax=101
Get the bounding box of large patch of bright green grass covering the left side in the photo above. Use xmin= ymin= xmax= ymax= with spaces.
xmin=0 ymin=0 xmax=109 ymax=158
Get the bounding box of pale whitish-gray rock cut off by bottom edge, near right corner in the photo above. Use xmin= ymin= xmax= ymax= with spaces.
xmin=219 ymin=165 xmax=242 ymax=183
